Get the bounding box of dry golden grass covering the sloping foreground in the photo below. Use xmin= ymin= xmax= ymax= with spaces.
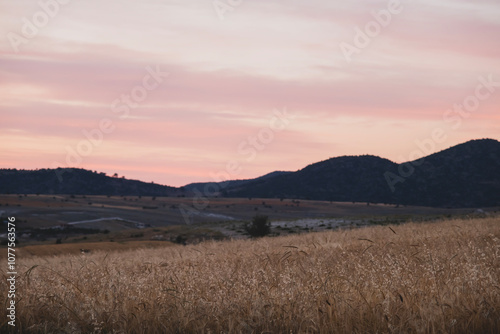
xmin=0 ymin=218 xmax=500 ymax=333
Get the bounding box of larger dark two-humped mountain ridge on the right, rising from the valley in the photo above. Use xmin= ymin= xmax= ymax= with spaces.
xmin=224 ymin=139 xmax=500 ymax=207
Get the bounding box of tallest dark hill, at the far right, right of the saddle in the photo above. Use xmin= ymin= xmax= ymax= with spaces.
xmin=388 ymin=139 xmax=500 ymax=207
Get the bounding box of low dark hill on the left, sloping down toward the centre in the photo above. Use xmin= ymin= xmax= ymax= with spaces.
xmin=0 ymin=168 xmax=181 ymax=196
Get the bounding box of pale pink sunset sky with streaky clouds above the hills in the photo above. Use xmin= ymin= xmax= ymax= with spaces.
xmin=0 ymin=0 xmax=500 ymax=186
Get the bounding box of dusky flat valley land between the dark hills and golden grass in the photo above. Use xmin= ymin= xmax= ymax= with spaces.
xmin=0 ymin=194 xmax=500 ymax=248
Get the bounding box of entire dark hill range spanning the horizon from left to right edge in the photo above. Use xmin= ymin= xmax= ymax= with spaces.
xmin=0 ymin=139 xmax=500 ymax=207
